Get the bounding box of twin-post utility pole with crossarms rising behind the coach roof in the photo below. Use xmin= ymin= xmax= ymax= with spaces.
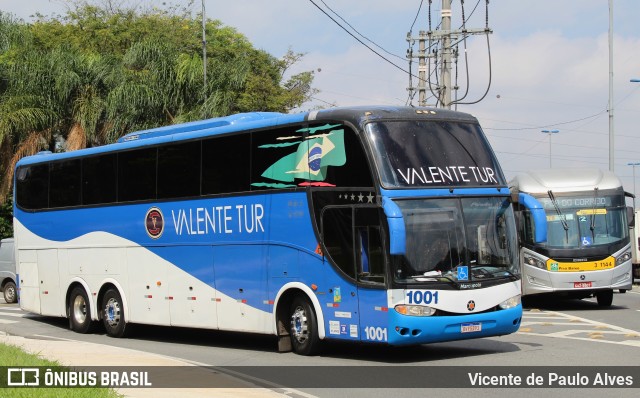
xmin=407 ymin=0 xmax=492 ymax=109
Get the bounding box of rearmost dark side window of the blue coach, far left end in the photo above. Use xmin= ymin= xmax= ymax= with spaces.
xmin=16 ymin=164 xmax=49 ymax=210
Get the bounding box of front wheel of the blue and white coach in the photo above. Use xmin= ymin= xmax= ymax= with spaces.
xmin=290 ymin=296 xmax=320 ymax=355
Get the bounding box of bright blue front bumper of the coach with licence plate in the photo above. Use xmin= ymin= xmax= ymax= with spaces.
xmin=388 ymin=304 xmax=522 ymax=346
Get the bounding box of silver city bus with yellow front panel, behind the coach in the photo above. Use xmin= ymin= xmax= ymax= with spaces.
xmin=509 ymin=169 xmax=633 ymax=307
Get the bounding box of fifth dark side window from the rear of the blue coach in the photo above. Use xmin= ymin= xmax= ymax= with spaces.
xmin=158 ymin=141 xmax=200 ymax=199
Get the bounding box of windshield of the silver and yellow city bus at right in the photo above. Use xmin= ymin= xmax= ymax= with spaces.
xmin=536 ymin=190 xmax=629 ymax=249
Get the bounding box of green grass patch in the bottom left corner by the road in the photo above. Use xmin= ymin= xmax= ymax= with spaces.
xmin=0 ymin=344 xmax=123 ymax=398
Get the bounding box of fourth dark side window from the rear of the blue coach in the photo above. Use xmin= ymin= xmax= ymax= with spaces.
xmin=118 ymin=148 xmax=157 ymax=202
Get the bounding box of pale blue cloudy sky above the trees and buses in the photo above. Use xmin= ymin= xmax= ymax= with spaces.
xmin=0 ymin=0 xmax=640 ymax=198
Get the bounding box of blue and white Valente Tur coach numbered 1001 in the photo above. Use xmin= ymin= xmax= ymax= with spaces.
xmin=14 ymin=107 xmax=536 ymax=355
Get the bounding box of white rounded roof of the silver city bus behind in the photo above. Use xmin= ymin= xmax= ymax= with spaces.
xmin=509 ymin=168 xmax=622 ymax=193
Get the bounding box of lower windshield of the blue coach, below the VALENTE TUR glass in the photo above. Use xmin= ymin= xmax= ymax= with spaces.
xmin=393 ymin=197 xmax=519 ymax=283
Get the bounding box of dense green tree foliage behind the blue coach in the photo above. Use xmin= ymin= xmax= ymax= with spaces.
xmin=0 ymin=0 xmax=315 ymax=205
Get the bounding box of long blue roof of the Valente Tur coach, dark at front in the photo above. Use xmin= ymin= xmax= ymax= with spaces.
xmin=16 ymin=106 xmax=477 ymax=167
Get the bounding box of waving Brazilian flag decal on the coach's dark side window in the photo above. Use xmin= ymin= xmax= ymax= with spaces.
xmin=262 ymin=125 xmax=347 ymax=182
